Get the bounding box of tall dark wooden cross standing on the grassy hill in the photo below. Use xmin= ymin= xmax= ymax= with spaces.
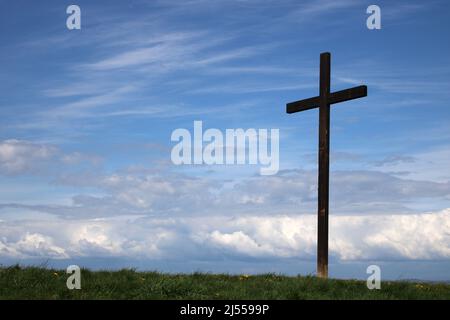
xmin=286 ymin=52 xmax=367 ymax=278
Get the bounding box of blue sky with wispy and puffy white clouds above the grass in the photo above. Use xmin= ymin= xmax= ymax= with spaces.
xmin=0 ymin=0 xmax=450 ymax=280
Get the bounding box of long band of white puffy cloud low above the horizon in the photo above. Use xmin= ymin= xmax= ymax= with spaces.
xmin=0 ymin=209 xmax=450 ymax=261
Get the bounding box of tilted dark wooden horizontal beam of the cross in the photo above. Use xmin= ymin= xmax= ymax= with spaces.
xmin=286 ymin=86 xmax=367 ymax=113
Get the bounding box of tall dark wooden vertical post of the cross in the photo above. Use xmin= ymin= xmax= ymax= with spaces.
xmin=317 ymin=52 xmax=330 ymax=278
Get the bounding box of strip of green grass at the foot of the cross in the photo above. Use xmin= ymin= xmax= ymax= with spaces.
xmin=0 ymin=266 xmax=450 ymax=299
